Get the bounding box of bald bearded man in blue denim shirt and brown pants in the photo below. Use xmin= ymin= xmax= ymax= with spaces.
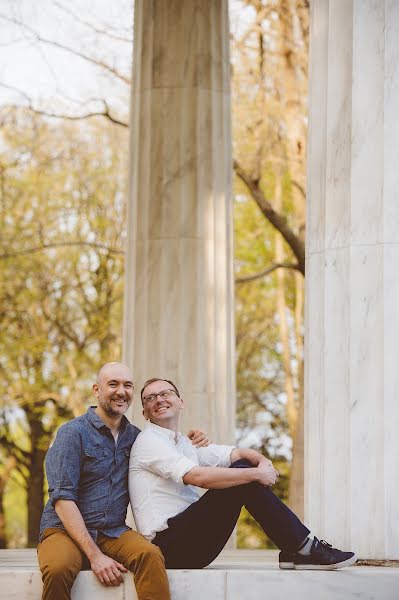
xmin=38 ymin=362 xmax=208 ymax=600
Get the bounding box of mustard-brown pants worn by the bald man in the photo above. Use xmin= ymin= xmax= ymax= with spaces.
xmin=37 ymin=528 xmax=170 ymax=600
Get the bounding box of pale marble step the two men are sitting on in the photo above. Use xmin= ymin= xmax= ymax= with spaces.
xmin=0 ymin=550 xmax=399 ymax=600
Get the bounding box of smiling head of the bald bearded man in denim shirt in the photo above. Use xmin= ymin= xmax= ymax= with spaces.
xmin=93 ymin=362 xmax=133 ymax=419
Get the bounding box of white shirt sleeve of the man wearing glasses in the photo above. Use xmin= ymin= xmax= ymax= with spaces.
xmin=129 ymin=433 xmax=198 ymax=483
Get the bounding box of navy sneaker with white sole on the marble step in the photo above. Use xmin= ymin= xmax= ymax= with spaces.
xmin=292 ymin=537 xmax=357 ymax=571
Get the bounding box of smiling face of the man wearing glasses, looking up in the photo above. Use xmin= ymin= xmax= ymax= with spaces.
xmin=143 ymin=379 xmax=183 ymax=430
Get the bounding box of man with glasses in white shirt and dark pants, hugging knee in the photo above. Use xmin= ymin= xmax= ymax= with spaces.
xmin=129 ymin=378 xmax=356 ymax=569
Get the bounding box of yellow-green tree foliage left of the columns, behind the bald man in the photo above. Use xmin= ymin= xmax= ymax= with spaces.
xmin=0 ymin=109 xmax=127 ymax=544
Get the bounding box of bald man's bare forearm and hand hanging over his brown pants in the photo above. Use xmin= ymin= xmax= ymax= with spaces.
xmin=55 ymin=500 xmax=127 ymax=585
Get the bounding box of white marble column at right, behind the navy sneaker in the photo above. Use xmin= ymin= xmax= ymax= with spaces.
xmin=305 ymin=0 xmax=399 ymax=559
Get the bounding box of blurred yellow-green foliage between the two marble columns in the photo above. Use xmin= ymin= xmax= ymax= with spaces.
xmin=230 ymin=0 xmax=307 ymax=547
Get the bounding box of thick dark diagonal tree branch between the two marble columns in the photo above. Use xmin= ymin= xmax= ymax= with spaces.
xmin=234 ymin=161 xmax=305 ymax=275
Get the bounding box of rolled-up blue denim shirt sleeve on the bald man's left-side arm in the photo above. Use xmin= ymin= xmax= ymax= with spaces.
xmin=46 ymin=424 xmax=82 ymax=506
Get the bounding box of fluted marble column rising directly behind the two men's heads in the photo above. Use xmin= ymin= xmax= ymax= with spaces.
xmin=124 ymin=0 xmax=235 ymax=442
